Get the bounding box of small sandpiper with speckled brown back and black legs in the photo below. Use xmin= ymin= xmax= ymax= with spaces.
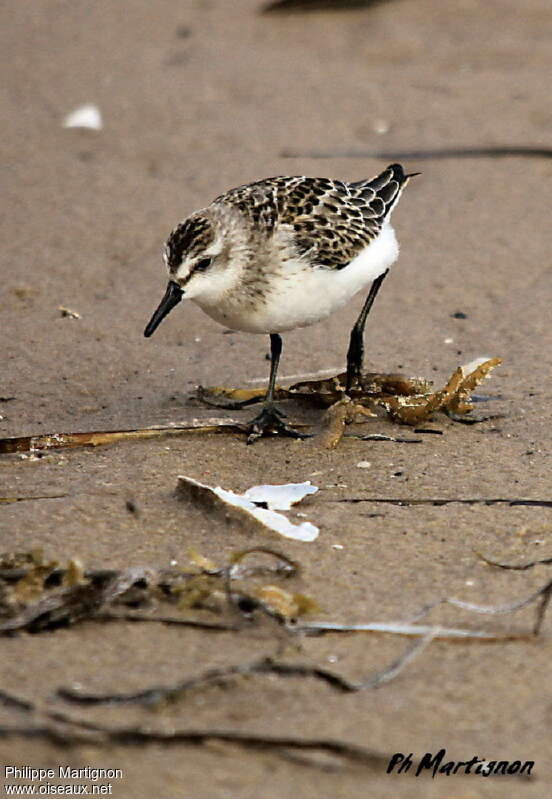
xmin=144 ymin=164 xmax=418 ymax=443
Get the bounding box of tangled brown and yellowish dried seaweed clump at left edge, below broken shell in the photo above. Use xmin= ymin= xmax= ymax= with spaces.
xmin=0 ymin=547 xmax=308 ymax=635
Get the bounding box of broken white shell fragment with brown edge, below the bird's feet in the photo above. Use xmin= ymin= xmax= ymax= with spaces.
xmin=177 ymin=475 xmax=320 ymax=542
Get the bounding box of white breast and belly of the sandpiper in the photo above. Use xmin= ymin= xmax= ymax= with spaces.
xmin=195 ymin=222 xmax=399 ymax=333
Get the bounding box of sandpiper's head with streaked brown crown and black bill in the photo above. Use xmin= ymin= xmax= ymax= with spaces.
xmin=144 ymin=206 xmax=244 ymax=337
